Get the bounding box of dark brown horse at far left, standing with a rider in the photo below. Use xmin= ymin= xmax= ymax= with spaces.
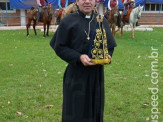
xmin=26 ymin=4 xmax=53 ymax=37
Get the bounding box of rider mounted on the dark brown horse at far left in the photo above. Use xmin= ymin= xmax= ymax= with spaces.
xmin=37 ymin=0 xmax=49 ymax=23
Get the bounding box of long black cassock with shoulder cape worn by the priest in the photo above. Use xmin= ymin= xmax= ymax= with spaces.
xmin=50 ymin=11 xmax=116 ymax=122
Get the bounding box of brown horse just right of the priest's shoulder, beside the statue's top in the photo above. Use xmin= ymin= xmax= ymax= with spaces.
xmin=104 ymin=6 xmax=119 ymax=37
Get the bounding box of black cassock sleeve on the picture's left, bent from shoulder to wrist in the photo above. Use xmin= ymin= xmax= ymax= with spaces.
xmin=50 ymin=21 xmax=81 ymax=65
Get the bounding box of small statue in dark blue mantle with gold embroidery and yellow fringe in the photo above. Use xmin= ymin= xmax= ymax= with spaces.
xmin=88 ymin=15 xmax=111 ymax=65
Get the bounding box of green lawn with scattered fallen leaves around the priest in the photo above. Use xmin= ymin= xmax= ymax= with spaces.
xmin=0 ymin=28 xmax=163 ymax=122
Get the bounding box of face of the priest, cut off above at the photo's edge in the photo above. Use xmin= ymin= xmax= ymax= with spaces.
xmin=76 ymin=0 xmax=95 ymax=15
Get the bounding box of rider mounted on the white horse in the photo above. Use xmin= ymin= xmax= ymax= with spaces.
xmin=122 ymin=0 xmax=135 ymax=24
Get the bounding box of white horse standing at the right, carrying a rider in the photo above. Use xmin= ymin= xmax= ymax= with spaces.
xmin=121 ymin=5 xmax=144 ymax=38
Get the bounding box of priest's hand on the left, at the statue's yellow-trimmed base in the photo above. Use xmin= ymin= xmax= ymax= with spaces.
xmin=80 ymin=54 xmax=95 ymax=66
